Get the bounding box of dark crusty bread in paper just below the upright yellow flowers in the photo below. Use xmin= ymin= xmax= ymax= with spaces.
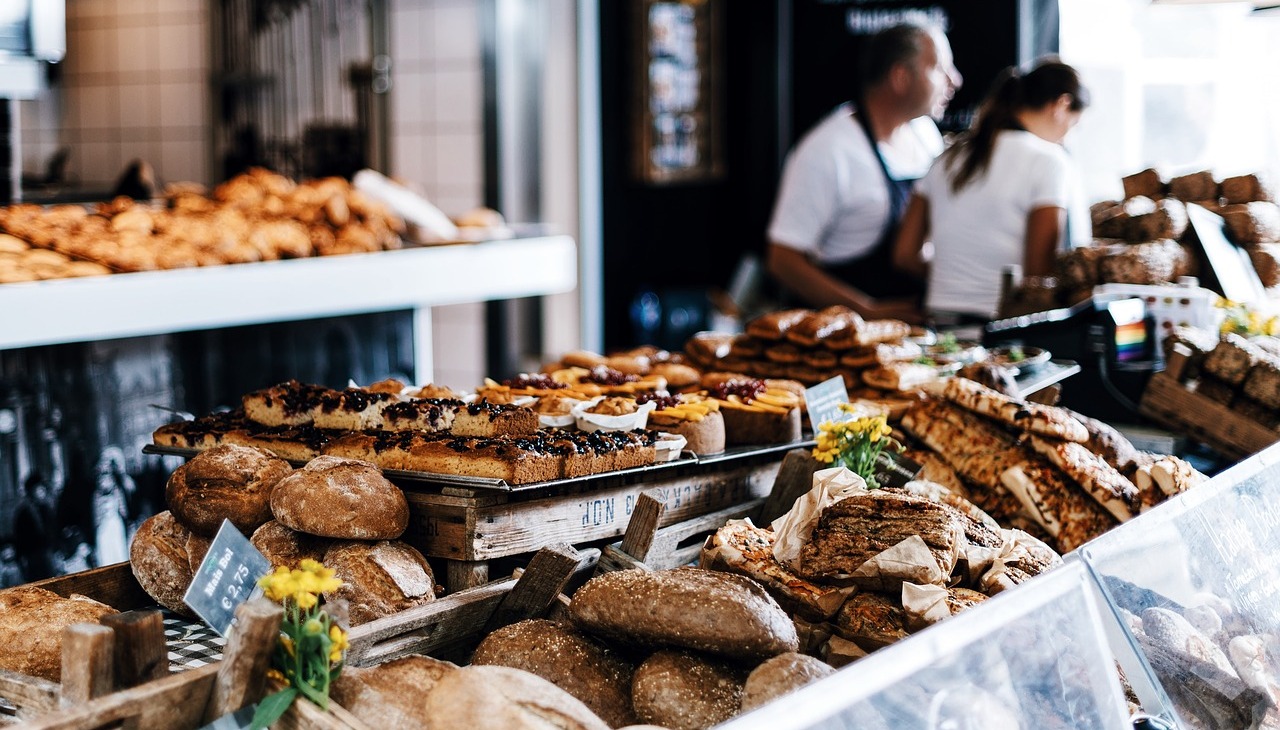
xmin=797 ymin=489 xmax=965 ymax=588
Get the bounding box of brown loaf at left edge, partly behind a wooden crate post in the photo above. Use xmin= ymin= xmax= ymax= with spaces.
xmin=0 ymin=585 xmax=115 ymax=681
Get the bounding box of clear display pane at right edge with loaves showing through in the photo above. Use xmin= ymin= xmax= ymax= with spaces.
xmin=1080 ymin=435 xmax=1280 ymax=727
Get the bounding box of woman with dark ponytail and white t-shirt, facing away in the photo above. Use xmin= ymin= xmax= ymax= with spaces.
xmin=893 ymin=59 xmax=1089 ymax=325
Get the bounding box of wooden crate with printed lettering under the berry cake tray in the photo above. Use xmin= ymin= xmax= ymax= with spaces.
xmin=401 ymin=452 xmax=782 ymax=593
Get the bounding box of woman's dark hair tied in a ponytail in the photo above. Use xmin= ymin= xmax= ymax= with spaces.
xmin=943 ymin=58 xmax=1089 ymax=192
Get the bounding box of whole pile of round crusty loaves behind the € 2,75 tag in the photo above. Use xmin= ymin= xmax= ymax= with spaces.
xmin=129 ymin=444 xmax=438 ymax=625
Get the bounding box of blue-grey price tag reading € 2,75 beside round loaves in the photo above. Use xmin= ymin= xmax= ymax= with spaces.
xmin=182 ymin=520 xmax=271 ymax=637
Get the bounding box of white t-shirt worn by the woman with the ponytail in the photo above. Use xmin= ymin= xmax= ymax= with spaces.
xmin=915 ymin=129 xmax=1075 ymax=316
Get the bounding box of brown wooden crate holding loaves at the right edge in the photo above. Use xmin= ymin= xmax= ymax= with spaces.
xmin=1138 ymin=346 xmax=1280 ymax=458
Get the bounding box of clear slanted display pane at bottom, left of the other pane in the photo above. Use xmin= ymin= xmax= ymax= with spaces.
xmin=719 ymin=562 xmax=1132 ymax=730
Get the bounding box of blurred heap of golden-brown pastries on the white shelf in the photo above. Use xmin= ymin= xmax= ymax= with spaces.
xmin=0 ymin=169 xmax=403 ymax=283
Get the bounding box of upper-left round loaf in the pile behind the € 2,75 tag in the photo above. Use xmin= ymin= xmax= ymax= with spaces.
xmin=165 ymin=443 xmax=293 ymax=535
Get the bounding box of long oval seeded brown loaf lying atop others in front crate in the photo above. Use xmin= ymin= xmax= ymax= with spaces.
xmin=570 ymin=567 xmax=800 ymax=660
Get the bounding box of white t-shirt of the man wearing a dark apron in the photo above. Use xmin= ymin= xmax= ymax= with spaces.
xmin=769 ymin=104 xmax=942 ymax=264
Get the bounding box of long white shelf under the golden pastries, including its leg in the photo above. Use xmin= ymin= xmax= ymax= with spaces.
xmin=0 ymin=236 xmax=577 ymax=383
